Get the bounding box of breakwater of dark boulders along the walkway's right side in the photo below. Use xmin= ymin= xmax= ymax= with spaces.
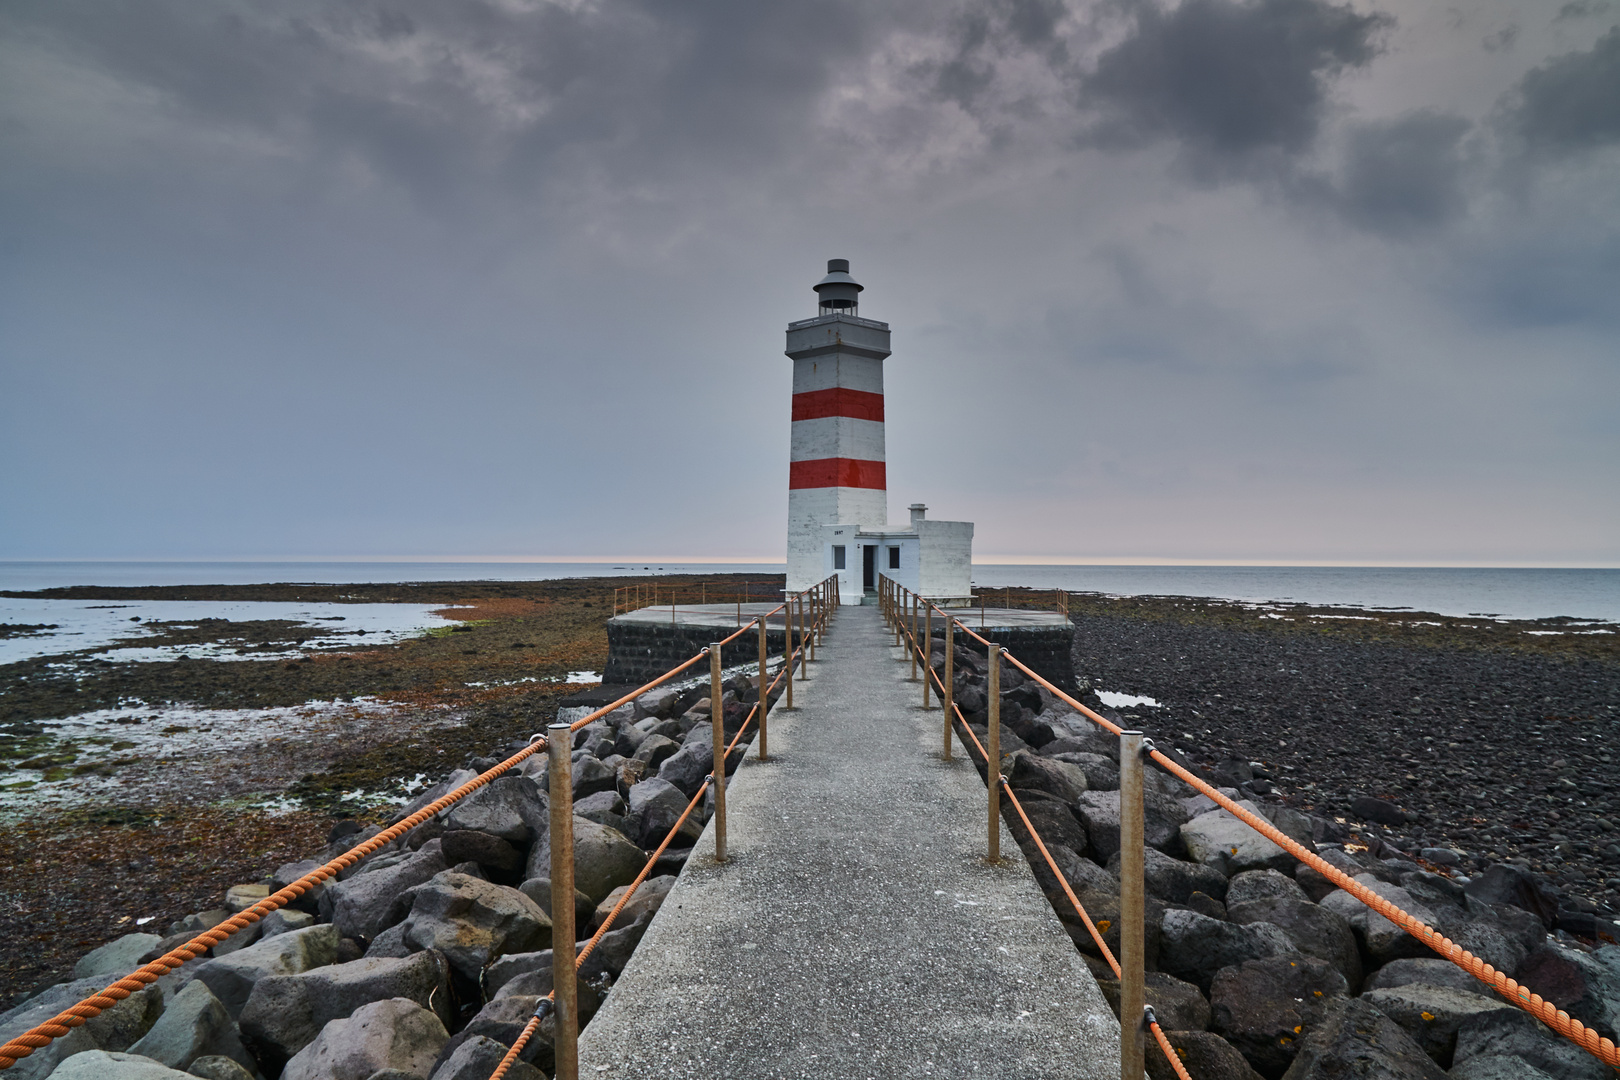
xmin=933 ymin=643 xmax=1620 ymax=1080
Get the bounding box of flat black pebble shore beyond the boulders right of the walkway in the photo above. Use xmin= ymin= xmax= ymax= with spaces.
xmin=1074 ymin=597 xmax=1620 ymax=913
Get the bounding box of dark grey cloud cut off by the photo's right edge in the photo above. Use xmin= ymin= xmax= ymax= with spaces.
xmin=1507 ymin=28 xmax=1620 ymax=155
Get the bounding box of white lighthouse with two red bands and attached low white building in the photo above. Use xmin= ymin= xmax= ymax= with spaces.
xmin=786 ymin=259 xmax=974 ymax=604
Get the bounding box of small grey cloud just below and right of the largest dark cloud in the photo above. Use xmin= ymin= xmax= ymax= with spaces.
xmin=1337 ymin=112 xmax=1471 ymax=236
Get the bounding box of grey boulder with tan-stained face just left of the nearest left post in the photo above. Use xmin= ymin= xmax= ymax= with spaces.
xmin=405 ymin=871 xmax=551 ymax=980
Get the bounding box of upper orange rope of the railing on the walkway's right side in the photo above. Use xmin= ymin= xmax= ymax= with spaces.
xmin=896 ymin=583 xmax=1620 ymax=1069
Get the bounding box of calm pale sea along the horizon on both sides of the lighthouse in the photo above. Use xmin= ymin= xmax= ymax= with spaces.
xmin=0 ymin=560 xmax=1620 ymax=622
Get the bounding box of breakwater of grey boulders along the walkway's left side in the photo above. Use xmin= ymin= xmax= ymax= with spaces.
xmin=0 ymin=677 xmax=784 ymax=1080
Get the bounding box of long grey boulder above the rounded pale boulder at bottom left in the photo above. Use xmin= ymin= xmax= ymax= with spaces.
xmin=241 ymin=952 xmax=452 ymax=1062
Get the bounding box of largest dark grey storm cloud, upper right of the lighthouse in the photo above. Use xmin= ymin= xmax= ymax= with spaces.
xmin=1082 ymin=0 xmax=1392 ymax=165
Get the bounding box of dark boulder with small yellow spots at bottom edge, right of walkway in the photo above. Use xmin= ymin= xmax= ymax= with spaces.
xmin=1210 ymin=957 xmax=1349 ymax=1077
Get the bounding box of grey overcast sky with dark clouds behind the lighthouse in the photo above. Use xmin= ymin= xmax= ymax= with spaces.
xmin=0 ymin=0 xmax=1620 ymax=565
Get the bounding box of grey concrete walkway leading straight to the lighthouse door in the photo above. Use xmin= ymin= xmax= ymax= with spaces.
xmin=580 ymin=607 xmax=1119 ymax=1080
